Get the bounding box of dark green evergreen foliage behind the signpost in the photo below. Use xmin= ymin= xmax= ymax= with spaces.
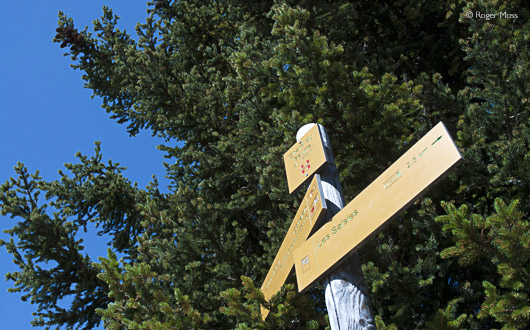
xmin=0 ymin=0 xmax=530 ymax=329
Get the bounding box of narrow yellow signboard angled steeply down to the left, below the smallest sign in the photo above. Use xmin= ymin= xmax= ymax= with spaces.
xmin=261 ymin=174 xmax=327 ymax=318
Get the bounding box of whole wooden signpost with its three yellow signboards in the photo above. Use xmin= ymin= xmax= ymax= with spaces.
xmin=261 ymin=122 xmax=462 ymax=330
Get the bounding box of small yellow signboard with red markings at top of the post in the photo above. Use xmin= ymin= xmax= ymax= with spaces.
xmin=283 ymin=125 xmax=326 ymax=194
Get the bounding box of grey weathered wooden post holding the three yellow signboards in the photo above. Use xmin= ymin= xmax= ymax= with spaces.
xmin=296 ymin=124 xmax=376 ymax=330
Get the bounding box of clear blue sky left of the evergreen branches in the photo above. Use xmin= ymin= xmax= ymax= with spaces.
xmin=0 ymin=0 xmax=173 ymax=330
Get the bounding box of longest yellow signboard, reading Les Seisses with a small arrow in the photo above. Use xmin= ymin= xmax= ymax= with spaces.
xmin=294 ymin=122 xmax=462 ymax=292
